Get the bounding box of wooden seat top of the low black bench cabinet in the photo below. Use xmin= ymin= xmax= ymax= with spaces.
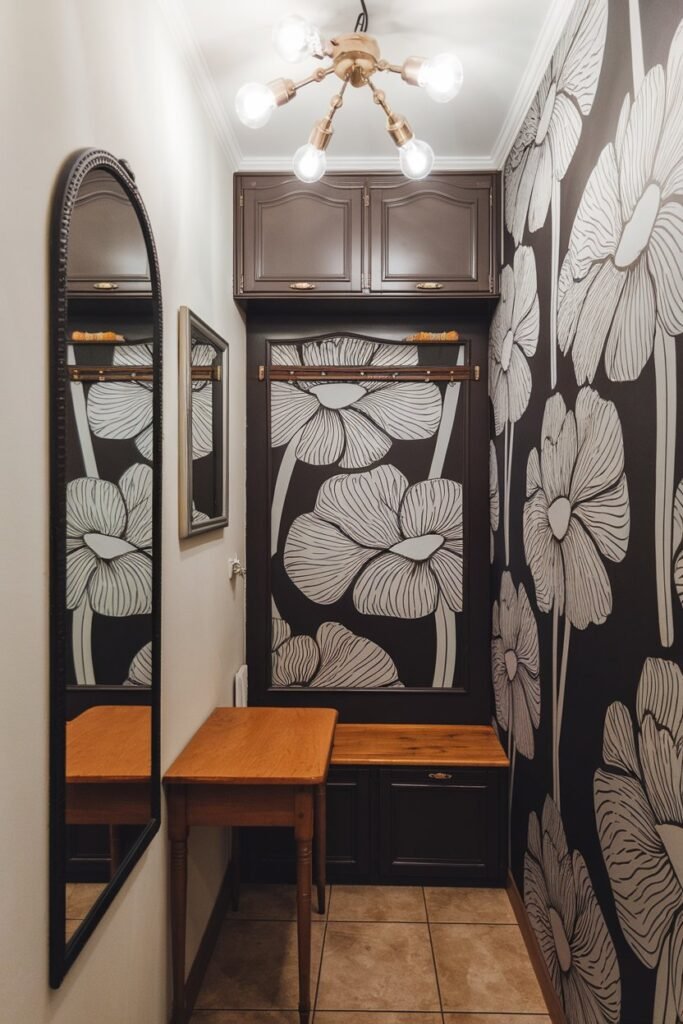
xmin=331 ymin=723 xmax=509 ymax=768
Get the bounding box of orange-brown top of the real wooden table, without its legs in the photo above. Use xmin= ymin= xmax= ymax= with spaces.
xmin=164 ymin=708 xmax=337 ymax=785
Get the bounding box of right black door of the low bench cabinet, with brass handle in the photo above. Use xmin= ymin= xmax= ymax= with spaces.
xmin=380 ymin=768 xmax=505 ymax=885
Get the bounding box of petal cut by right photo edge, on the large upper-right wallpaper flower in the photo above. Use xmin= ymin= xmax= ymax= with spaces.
xmin=647 ymin=201 xmax=683 ymax=338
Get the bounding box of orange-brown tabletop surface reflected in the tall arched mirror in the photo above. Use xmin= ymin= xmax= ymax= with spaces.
xmin=67 ymin=705 xmax=152 ymax=783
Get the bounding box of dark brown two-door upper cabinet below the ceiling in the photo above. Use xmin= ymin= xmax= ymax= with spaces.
xmin=234 ymin=172 xmax=498 ymax=298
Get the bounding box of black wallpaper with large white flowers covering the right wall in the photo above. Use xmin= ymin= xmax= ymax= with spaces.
xmin=489 ymin=0 xmax=683 ymax=1024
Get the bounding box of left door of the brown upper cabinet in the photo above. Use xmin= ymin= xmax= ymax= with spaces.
xmin=239 ymin=177 xmax=364 ymax=295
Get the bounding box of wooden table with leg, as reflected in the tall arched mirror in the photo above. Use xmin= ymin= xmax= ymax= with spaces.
xmin=66 ymin=705 xmax=152 ymax=874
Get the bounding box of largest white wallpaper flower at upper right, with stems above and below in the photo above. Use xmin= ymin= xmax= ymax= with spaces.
xmin=558 ymin=18 xmax=683 ymax=646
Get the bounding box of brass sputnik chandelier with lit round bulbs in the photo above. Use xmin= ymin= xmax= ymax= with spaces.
xmin=234 ymin=0 xmax=463 ymax=181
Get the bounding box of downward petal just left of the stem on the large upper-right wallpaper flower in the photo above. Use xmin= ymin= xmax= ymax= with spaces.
xmin=605 ymin=259 xmax=656 ymax=381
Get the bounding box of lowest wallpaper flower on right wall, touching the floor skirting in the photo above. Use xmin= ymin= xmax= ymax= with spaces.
xmin=524 ymin=797 xmax=622 ymax=1024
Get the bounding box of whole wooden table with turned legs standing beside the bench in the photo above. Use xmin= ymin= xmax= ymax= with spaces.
xmin=164 ymin=708 xmax=337 ymax=1024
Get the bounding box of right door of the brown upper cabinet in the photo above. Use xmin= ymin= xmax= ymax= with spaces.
xmin=370 ymin=175 xmax=494 ymax=295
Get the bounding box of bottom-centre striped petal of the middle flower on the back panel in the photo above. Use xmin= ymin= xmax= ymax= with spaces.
xmin=353 ymin=552 xmax=438 ymax=618
